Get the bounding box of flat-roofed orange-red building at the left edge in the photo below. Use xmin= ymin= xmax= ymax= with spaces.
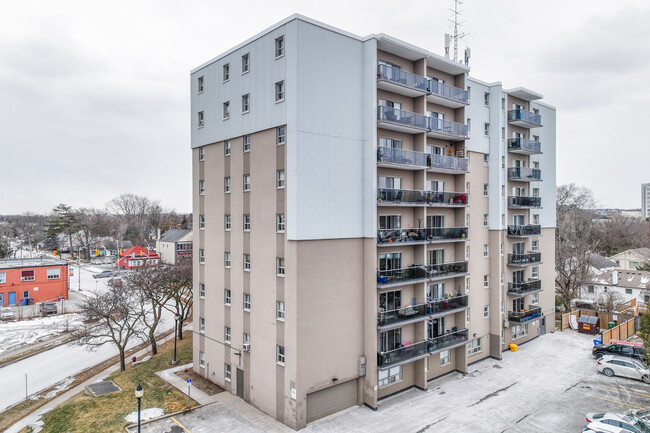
xmin=0 ymin=258 xmax=68 ymax=307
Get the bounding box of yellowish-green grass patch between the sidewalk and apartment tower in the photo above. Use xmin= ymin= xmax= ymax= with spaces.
xmin=37 ymin=331 xmax=197 ymax=433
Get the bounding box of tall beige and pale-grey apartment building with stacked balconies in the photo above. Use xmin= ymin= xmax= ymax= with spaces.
xmin=191 ymin=15 xmax=555 ymax=429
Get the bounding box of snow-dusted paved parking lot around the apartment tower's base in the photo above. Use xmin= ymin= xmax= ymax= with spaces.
xmin=134 ymin=331 xmax=650 ymax=433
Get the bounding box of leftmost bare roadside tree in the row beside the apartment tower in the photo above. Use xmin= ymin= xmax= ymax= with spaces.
xmin=73 ymin=284 xmax=143 ymax=371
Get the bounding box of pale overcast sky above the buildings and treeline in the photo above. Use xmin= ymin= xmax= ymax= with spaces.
xmin=0 ymin=0 xmax=650 ymax=214
